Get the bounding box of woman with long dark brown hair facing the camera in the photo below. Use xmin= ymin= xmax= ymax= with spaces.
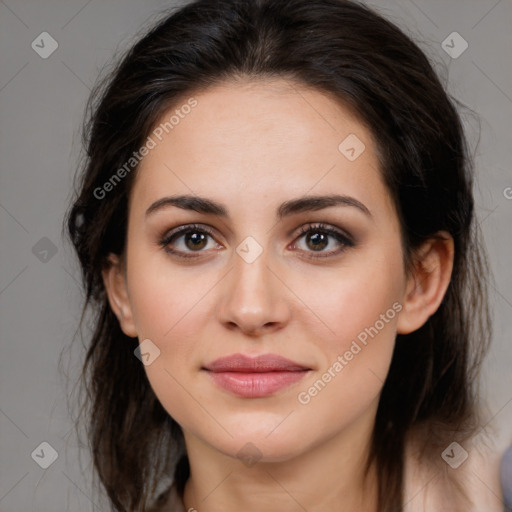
xmin=67 ymin=0 xmax=503 ymax=512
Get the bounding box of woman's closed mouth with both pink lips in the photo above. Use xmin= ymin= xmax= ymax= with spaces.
xmin=202 ymin=354 xmax=311 ymax=398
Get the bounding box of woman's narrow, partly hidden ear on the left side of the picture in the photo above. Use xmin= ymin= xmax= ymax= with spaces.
xmin=102 ymin=253 xmax=137 ymax=338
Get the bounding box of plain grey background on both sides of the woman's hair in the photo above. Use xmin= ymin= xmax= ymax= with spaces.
xmin=0 ymin=0 xmax=512 ymax=512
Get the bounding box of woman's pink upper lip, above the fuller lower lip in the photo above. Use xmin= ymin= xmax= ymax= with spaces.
xmin=204 ymin=354 xmax=310 ymax=373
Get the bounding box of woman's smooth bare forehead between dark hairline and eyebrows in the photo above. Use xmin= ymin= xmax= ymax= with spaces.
xmin=131 ymin=79 xmax=385 ymax=216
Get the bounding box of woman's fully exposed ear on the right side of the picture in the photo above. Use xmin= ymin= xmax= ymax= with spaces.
xmin=397 ymin=231 xmax=454 ymax=334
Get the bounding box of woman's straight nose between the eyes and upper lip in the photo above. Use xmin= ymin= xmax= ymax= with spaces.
xmin=216 ymin=244 xmax=290 ymax=336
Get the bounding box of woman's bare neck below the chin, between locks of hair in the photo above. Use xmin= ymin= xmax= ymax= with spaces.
xmin=183 ymin=410 xmax=377 ymax=512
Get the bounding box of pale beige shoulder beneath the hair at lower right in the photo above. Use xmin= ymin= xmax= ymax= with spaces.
xmin=404 ymin=436 xmax=504 ymax=512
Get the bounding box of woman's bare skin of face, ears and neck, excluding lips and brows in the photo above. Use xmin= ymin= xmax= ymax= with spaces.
xmin=104 ymin=79 xmax=453 ymax=512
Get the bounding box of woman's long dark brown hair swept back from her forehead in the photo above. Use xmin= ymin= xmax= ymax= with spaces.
xmin=66 ymin=0 xmax=490 ymax=512
